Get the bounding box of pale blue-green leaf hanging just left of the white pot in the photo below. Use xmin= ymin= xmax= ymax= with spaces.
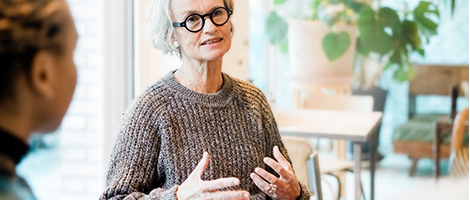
xmin=266 ymin=11 xmax=288 ymax=45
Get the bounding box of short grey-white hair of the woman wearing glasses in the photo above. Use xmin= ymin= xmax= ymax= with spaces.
xmin=145 ymin=0 xmax=233 ymax=58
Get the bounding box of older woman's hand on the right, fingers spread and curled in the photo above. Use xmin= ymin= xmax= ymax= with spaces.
xmin=250 ymin=146 xmax=300 ymax=200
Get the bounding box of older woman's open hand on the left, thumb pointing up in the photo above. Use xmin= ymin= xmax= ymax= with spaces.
xmin=176 ymin=152 xmax=250 ymax=200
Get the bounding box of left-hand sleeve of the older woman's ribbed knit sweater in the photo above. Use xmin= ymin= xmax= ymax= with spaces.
xmin=100 ymin=96 xmax=178 ymax=200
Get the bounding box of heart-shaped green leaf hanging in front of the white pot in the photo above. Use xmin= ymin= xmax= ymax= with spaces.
xmin=322 ymin=31 xmax=351 ymax=62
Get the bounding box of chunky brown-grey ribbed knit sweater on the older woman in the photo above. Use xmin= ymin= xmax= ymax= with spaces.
xmin=101 ymin=72 xmax=309 ymax=199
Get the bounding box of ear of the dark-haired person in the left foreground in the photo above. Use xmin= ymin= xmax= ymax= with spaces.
xmin=28 ymin=51 xmax=55 ymax=98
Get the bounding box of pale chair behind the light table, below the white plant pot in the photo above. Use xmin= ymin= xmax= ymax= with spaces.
xmin=297 ymin=94 xmax=374 ymax=199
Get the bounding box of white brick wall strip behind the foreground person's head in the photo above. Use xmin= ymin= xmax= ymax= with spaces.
xmin=59 ymin=0 xmax=104 ymax=200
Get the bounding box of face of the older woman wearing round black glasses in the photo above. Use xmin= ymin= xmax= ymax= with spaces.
xmin=171 ymin=0 xmax=232 ymax=61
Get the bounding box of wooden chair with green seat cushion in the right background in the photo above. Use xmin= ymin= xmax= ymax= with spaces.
xmin=393 ymin=65 xmax=469 ymax=176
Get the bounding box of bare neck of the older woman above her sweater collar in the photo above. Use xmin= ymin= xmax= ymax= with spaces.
xmin=175 ymin=59 xmax=223 ymax=93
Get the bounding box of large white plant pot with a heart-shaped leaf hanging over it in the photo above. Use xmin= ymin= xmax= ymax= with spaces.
xmin=288 ymin=20 xmax=357 ymax=84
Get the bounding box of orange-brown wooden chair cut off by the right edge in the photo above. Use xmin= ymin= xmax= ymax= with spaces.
xmin=449 ymin=108 xmax=469 ymax=177
